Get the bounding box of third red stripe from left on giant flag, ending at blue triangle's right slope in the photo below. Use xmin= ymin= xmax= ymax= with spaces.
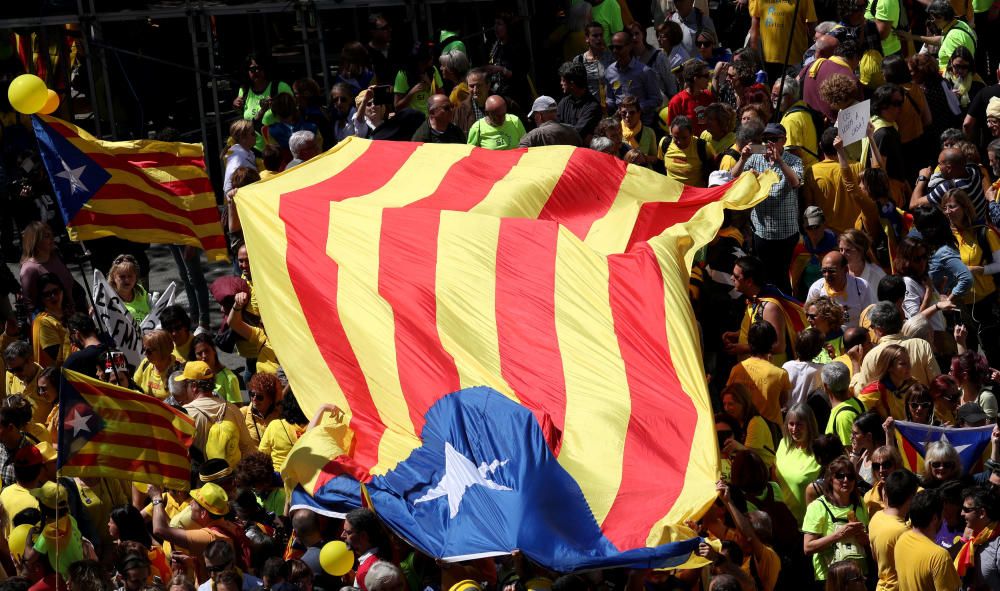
xmin=496 ymin=218 xmax=566 ymax=455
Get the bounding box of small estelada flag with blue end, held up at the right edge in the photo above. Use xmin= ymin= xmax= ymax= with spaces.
xmin=895 ymin=421 xmax=993 ymax=474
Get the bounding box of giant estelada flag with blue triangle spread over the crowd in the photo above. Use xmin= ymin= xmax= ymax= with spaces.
xmin=237 ymin=138 xmax=774 ymax=571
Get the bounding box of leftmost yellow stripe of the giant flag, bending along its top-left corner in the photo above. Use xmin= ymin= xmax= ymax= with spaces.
xmin=236 ymin=138 xmax=372 ymax=417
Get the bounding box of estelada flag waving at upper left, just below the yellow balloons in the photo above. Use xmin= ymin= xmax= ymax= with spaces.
xmin=31 ymin=115 xmax=228 ymax=261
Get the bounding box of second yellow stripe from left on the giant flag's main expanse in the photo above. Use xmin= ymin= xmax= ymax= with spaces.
xmin=326 ymin=202 xmax=420 ymax=474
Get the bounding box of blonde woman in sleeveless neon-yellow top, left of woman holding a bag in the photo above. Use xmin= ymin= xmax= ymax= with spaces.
xmin=775 ymin=403 xmax=820 ymax=523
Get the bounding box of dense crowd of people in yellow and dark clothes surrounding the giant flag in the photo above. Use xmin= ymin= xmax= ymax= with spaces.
xmin=0 ymin=0 xmax=1000 ymax=591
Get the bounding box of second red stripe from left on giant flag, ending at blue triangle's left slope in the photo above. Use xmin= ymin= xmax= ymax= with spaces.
xmin=378 ymin=207 xmax=462 ymax=435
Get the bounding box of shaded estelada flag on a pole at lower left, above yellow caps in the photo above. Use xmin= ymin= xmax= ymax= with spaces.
xmin=56 ymin=369 xmax=194 ymax=490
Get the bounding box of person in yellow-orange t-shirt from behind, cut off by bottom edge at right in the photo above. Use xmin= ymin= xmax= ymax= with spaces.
xmin=892 ymin=490 xmax=962 ymax=591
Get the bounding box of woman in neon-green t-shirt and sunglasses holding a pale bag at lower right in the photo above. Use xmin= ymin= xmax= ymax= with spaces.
xmin=802 ymin=456 xmax=870 ymax=581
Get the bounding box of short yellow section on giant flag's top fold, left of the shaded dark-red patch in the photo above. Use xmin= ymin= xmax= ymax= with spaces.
xmin=470 ymin=146 xmax=575 ymax=219
